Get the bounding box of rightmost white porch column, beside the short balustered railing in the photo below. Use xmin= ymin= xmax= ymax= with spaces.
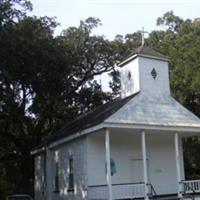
xmin=174 ymin=133 xmax=182 ymax=198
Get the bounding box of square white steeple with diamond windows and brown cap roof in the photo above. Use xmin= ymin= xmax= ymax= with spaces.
xmin=119 ymin=45 xmax=170 ymax=97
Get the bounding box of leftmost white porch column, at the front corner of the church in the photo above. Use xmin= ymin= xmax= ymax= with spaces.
xmin=105 ymin=129 xmax=112 ymax=200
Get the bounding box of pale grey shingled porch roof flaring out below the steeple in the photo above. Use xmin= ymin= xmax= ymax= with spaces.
xmin=105 ymin=93 xmax=200 ymax=128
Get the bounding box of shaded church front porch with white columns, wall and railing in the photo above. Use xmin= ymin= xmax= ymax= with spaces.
xmin=87 ymin=128 xmax=199 ymax=199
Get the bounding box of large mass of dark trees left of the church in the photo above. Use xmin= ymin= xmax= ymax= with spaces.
xmin=0 ymin=1 xmax=114 ymax=198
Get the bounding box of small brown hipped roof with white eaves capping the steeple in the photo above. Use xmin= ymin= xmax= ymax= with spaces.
xmin=119 ymin=45 xmax=169 ymax=66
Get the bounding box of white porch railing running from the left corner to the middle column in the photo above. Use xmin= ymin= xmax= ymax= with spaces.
xmin=88 ymin=183 xmax=144 ymax=200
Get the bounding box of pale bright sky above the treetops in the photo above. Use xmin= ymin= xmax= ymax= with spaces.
xmin=31 ymin=0 xmax=200 ymax=39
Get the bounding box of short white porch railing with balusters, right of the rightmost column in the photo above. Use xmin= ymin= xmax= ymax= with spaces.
xmin=182 ymin=180 xmax=200 ymax=194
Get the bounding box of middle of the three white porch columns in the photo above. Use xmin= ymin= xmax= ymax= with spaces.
xmin=141 ymin=131 xmax=149 ymax=200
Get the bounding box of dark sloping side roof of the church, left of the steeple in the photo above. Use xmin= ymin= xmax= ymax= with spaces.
xmin=41 ymin=93 xmax=138 ymax=144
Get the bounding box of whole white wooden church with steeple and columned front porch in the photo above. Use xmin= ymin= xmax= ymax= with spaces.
xmin=32 ymin=46 xmax=200 ymax=200
